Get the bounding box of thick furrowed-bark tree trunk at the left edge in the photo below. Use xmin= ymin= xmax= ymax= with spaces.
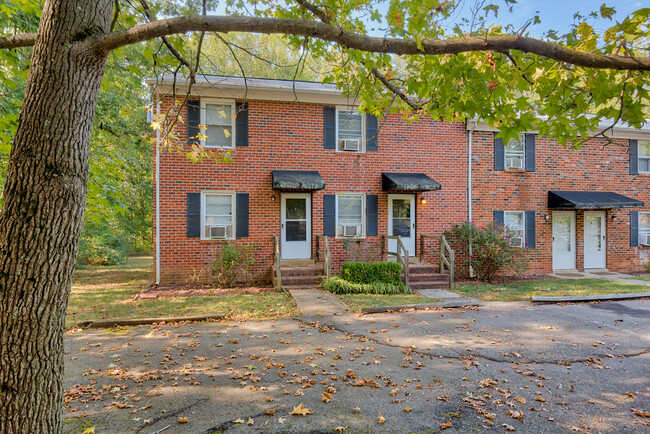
xmin=0 ymin=0 xmax=113 ymax=433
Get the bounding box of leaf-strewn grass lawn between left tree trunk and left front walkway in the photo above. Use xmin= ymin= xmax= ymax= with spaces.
xmin=66 ymin=257 xmax=297 ymax=328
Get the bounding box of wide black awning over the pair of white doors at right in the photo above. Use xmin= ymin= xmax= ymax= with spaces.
xmin=548 ymin=191 xmax=643 ymax=209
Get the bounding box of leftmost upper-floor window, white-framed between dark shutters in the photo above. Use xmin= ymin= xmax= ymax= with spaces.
xmin=201 ymin=98 xmax=235 ymax=148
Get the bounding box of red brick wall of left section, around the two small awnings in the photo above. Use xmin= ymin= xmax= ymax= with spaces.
xmin=154 ymin=100 xmax=467 ymax=284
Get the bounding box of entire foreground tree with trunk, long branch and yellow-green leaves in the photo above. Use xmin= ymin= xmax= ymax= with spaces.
xmin=0 ymin=0 xmax=650 ymax=432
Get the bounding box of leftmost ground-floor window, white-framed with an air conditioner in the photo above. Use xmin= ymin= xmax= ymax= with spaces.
xmin=201 ymin=192 xmax=236 ymax=240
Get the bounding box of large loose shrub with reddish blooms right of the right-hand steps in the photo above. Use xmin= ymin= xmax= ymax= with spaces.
xmin=445 ymin=222 xmax=528 ymax=282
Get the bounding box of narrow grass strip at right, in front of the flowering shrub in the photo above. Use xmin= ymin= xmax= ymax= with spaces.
xmin=454 ymin=279 xmax=648 ymax=301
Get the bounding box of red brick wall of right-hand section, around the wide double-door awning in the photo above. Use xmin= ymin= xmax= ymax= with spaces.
xmin=472 ymin=132 xmax=650 ymax=273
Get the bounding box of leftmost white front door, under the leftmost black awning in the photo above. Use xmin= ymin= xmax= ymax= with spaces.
xmin=280 ymin=193 xmax=311 ymax=259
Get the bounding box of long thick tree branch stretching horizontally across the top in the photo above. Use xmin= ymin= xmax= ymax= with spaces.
xmin=5 ymin=15 xmax=650 ymax=71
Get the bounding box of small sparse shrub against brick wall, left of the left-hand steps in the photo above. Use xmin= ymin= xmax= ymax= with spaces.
xmin=212 ymin=241 xmax=255 ymax=288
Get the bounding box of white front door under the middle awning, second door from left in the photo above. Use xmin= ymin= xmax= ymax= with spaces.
xmin=388 ymin=194 xmax=415 ymax=256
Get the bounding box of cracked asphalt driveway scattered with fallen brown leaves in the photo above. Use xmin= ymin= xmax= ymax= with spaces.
xmin=65 ymin=300 xmax=650 ymax=434
